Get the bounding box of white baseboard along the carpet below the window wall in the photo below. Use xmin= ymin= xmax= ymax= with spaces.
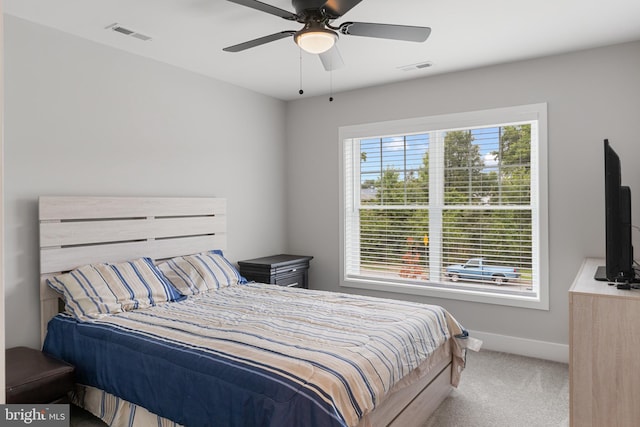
xmin=469 ymin=331 xmax=569 ymax=363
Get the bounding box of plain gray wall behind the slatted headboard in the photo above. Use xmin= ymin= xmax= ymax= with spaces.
xmin=4 ymin=16 xmax=286 ymax=347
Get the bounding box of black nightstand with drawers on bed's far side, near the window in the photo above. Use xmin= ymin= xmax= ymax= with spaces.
xmin=238 ymin=254 xmax=313 ymax=289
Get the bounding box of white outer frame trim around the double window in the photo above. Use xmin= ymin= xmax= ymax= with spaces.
xmin=338 ymin=103 xmax=549 ymax=310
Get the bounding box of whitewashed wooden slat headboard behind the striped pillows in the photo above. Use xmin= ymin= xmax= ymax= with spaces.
xmin=39 ymin=196 xmax=227 ymax=340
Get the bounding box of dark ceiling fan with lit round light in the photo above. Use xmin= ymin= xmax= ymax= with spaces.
xmin=222 ymin=0 xmax=431 ymax=71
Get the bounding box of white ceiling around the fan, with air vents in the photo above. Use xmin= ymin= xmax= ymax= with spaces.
xmin=4 ymin=0 xmax=640 ymax=100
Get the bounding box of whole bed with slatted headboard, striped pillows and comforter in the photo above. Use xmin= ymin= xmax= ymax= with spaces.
xmin=39 ymin=197 xmax=468 ymax=427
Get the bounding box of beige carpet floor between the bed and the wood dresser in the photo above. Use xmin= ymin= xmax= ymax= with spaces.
xmin=424 ymin=350 xmax=569 ymax=427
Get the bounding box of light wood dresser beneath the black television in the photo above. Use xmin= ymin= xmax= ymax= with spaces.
xmin=569 ymin=258 xmax=640 ymax=427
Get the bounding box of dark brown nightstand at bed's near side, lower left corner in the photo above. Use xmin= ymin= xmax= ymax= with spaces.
xmin=5 ymin=347 xmax=74 ymax=403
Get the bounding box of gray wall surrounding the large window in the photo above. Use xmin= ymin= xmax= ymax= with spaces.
xmin=286 ymin=42 xmax=640 ymax=350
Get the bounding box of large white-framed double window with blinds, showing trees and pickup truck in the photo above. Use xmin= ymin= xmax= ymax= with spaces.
xmin=340 ymin=104 xmax=548 ymax=309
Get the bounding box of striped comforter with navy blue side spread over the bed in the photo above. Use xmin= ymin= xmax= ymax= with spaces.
xmin=44 ymin=283 xmax=464 ymax=427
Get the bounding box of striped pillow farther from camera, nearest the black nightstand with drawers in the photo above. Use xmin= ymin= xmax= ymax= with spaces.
xmin=158 ymin=250 xmax=246 ymax=295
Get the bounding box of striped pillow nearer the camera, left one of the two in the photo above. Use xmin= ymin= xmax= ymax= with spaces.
xmin=47 ymin=258 xmax=184 ymax=320
